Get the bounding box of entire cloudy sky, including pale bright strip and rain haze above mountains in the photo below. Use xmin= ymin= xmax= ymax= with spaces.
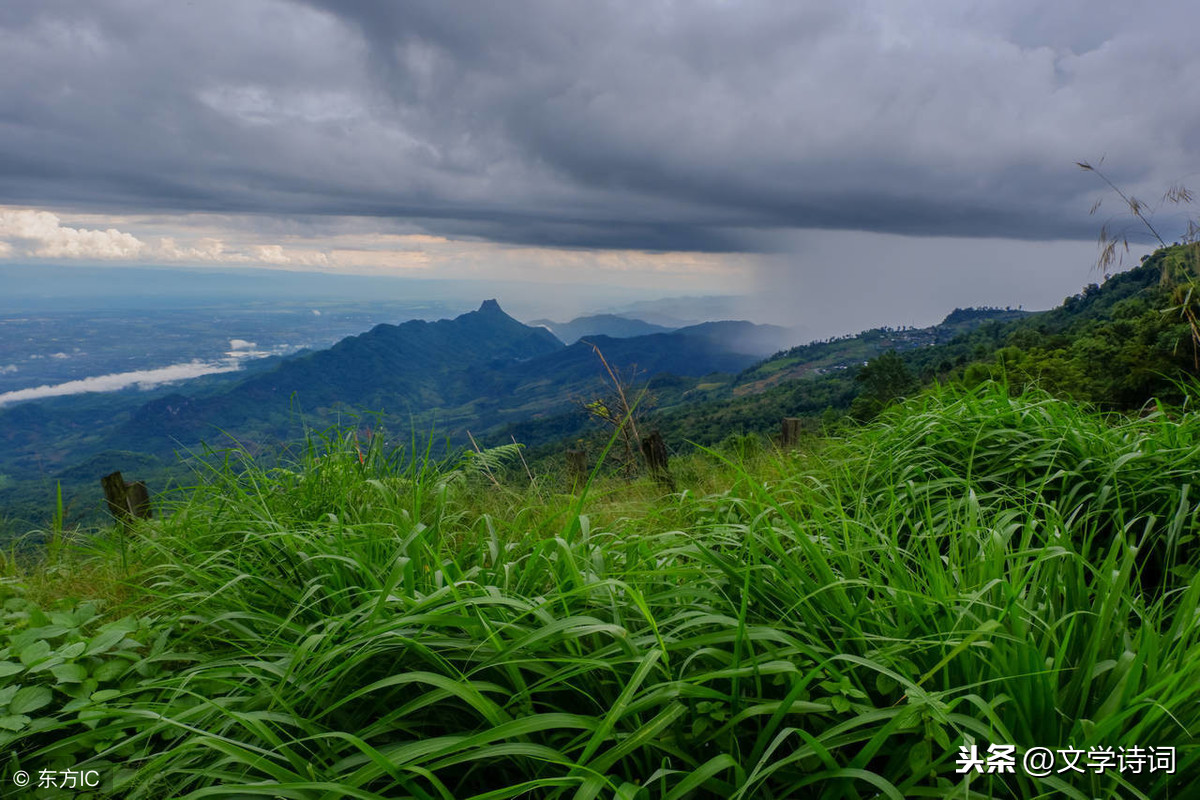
xmin=0 ymin=0 xmax=1200 ymax=336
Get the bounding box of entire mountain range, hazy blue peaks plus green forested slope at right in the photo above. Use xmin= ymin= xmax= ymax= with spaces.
xmin=7 ymin=244 xmax=1186 ymax=534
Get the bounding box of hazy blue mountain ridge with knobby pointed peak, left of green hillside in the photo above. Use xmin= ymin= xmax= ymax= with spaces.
xmin=0 ymin=300 xmax=782 ymax=505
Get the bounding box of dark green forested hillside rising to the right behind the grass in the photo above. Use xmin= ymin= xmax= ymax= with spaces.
xmin=600 ymin=246 xmax=1200 ymax=446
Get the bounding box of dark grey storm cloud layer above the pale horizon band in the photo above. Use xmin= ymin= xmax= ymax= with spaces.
xmin=0 ymin=0 xmax=1200 ymax=251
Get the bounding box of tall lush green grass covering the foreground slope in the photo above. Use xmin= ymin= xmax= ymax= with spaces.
xmin=0 ymin=387 xmax=1200 ymax=799
